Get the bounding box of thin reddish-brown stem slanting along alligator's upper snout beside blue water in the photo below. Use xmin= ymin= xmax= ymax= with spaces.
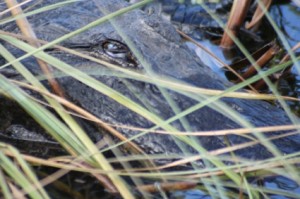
xmin=176 ymin=30 xmax=259 ymax=93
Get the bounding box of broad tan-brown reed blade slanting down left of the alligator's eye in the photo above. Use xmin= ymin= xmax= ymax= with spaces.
xmin=5 ymin=0 xmax=64 ymax=97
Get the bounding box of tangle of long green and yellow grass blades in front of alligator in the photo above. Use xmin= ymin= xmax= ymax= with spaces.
xmin=0 ymin=0 xmax=300 ymax=198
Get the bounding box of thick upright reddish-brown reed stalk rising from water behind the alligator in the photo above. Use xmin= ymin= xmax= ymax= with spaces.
xmin=220 ymin=0 xmax=251 ymax=48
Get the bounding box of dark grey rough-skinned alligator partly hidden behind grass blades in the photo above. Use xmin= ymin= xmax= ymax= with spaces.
xmin=0 ymin=0 xmax=300 ymax=162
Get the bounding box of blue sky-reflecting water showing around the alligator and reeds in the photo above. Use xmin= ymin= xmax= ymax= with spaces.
xmin=162 ymin=1 xmax=300 ymax=199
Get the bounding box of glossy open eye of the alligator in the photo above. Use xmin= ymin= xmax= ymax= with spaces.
xmin=102 ymin=40 xmax=130 ymax=59
